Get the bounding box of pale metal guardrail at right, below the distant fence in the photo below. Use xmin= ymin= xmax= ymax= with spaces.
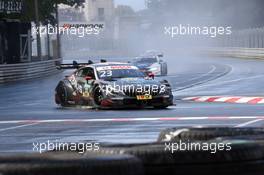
xmin=206 ymin=47 xmax=264 ymax=59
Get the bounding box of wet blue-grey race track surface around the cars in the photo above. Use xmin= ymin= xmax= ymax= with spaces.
xmin=0 ymin=58 xmax=264 ymax=153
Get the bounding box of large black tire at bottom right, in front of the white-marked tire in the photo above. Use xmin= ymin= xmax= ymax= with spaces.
xmin=84 ymin=140 xmax=264 ymax=175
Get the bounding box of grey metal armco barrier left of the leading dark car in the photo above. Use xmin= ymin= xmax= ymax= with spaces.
xmin=0 ymin=59 xmax=61 ymax=83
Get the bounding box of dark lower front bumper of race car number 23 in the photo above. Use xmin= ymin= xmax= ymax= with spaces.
xmin=101 ymin=95 xmax=173 ymax=108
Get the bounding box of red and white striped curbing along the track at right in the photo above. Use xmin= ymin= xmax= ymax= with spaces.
xmin=182 ymin=96 xmax=264 ymax=104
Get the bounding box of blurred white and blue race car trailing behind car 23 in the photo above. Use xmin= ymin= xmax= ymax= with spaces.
xmin=132 ymin=51 xmax=168 ymax=76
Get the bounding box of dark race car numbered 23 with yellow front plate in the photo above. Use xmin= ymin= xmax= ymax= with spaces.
xmin=55 ymin=60 xmax=173 ymax=108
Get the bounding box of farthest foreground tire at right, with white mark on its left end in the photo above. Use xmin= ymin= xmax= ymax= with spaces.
xmin=157 ymin=127 xmax=264 ymax=142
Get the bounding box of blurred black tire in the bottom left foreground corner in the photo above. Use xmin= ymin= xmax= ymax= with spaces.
xmin=0 ymin=152 xmax=143 ymax=175
